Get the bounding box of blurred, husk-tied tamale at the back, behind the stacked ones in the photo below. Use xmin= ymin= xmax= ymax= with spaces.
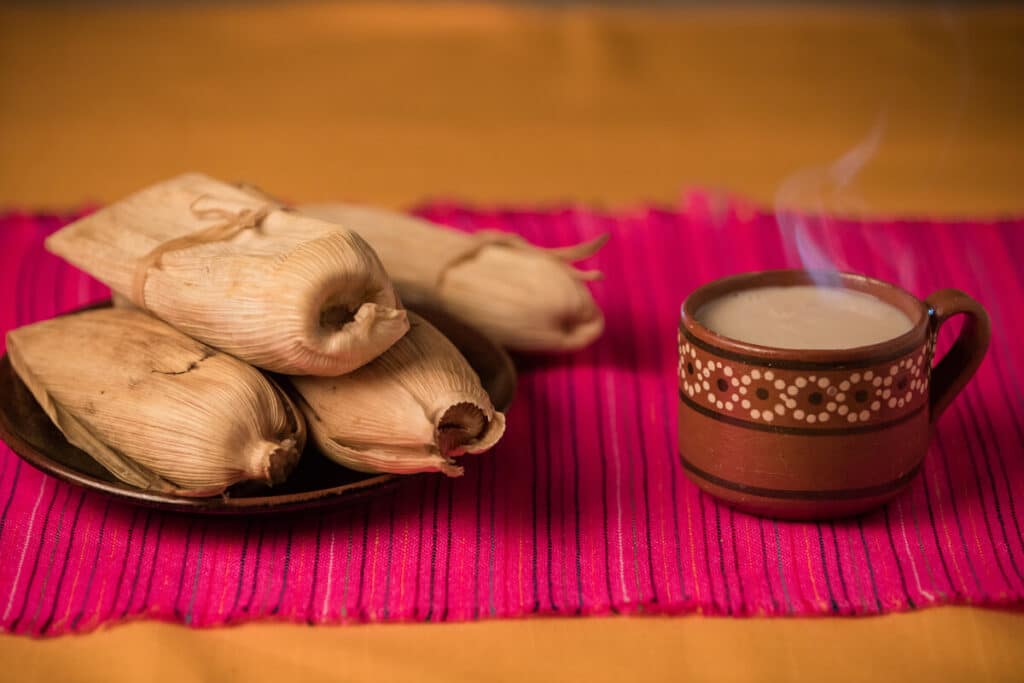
xmin=298 ymin=204 xmax=605 ymax=351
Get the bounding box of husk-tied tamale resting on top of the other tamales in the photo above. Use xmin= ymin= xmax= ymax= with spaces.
xmin=46 ymin=173 xmax=409 ymax=375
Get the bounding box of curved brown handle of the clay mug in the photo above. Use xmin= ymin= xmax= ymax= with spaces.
xmin=925 ymin=289 xmax=991 ymax=424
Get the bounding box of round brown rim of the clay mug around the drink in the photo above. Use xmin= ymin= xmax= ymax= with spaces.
xmin=679 ymin=268 xmax=930 ymax=369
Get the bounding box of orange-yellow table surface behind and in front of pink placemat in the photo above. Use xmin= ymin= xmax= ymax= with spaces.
xmin=0 ymin=2 xmax=1024 ymax=682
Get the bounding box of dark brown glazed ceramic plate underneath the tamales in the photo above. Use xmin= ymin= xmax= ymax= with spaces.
xmin=0 ymin=306 xmax=516 ymax=514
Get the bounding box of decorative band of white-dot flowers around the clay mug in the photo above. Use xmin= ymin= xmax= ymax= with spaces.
xmin=678 ymin=332 xmax=934 ymax=428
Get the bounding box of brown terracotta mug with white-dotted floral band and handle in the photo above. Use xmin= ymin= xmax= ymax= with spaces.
xmin=678 ymin=270 xmax=990 ymax=519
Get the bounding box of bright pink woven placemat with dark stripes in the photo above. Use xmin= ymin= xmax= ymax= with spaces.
xmin=0 ymin=194 xmax=1024 ymax=635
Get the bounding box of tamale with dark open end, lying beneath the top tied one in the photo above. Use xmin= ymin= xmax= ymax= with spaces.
xmin=290 ymin=313 xmax=505 ymax=476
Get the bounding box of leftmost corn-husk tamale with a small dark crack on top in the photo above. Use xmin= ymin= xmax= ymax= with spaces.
xmin=7 ymin=309 xmax=306 ymax=497
